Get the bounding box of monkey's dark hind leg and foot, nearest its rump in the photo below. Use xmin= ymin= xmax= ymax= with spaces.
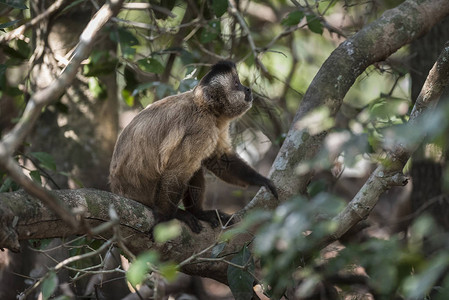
xmin=154 ymin=176 xmax=203 ymax=233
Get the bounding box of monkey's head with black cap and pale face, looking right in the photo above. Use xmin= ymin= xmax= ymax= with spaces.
xmin=194 ymin=61 xmax=253 ymax=118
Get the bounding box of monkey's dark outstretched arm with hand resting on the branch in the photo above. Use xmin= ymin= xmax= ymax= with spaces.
xmin=203 ymin=153 xmax=278 ymax=198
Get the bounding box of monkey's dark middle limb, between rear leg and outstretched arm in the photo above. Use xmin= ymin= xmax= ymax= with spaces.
xmin=183 ymin=168 xmax=232 ymax=228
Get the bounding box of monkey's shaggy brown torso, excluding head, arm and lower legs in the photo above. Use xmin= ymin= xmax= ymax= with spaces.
xmin=109 ymin=92 xmax=219 ymax=207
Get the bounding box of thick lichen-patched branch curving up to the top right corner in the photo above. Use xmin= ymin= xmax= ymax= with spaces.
xmin=246 ymin=0 xmax=449 ymax=210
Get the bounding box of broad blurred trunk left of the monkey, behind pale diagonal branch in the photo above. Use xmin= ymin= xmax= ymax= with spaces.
xmin=28 ymin=0 xmax=118 ymax=190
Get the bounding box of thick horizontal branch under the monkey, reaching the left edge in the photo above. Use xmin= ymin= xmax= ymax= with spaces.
xmin=0 ymin=189 xmax=245 ymax=282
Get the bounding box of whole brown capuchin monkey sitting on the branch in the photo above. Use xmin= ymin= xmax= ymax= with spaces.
xmin=109 ymin=61 xmax=278 ymax=233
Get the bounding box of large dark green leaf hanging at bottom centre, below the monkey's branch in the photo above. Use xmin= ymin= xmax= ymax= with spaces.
xmin=227 ymin=247 xmax=254 ymax=300
